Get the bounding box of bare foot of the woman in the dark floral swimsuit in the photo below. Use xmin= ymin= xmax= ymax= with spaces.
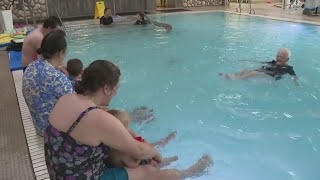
xmin=182 ymin=155 xmax=213 ymax=178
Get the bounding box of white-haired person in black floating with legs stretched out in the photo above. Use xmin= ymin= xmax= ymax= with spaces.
xmin=219 ymin=48 xmax=298 ymax=85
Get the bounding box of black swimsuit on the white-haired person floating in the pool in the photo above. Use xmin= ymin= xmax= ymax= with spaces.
xmin=256 ymin=60 xmax=296 ymax=80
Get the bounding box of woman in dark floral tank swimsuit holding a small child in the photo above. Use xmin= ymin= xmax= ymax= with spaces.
xmin=44 ymin=60 xmax=214 ymax=180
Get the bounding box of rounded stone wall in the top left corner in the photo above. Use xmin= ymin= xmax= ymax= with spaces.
xmin=0 ymin=0 xmax=48 ymax=21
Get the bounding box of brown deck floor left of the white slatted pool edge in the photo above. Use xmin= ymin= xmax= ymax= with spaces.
xmin=0 ymin=49 xmax=35 ymax=179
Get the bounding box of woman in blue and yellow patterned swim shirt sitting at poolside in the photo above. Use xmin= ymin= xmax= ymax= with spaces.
xmin=22 ymin=30 xmax=73 ymax=136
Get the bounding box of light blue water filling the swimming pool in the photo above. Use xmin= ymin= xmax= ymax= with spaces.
xmin=67 ymin=12 xmax=320 ymax=180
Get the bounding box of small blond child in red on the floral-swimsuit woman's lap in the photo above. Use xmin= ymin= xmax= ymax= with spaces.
xmin=108 ymin=110 xmax=178 ymax=168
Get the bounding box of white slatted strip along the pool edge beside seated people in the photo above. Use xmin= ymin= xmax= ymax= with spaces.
xmin=12 ymin=71 xmax=50 ymax=180
